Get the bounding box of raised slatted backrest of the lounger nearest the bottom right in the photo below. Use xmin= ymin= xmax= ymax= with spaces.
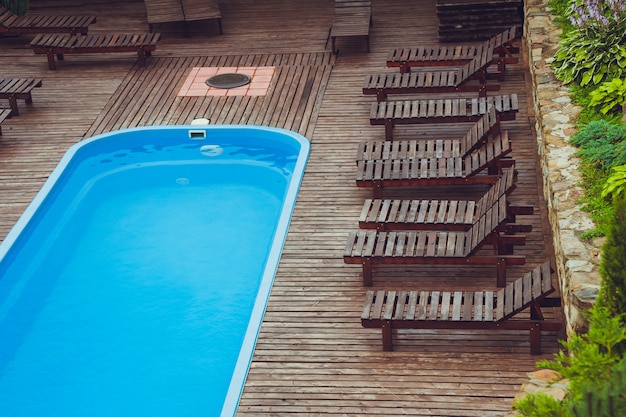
xmin=494 ymin=261 xmax=554 ymax=321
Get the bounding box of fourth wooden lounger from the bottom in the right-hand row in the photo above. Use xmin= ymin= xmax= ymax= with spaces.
xmin=356 ymin=131 xmax=512 ymax=198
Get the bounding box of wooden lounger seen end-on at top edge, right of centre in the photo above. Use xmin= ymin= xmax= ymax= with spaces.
xmin=326 ymin=0 xmax=372 ymax=54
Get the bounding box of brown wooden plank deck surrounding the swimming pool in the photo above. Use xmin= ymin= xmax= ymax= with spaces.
xmin=0 ymin=0 xmax=563 ymax=416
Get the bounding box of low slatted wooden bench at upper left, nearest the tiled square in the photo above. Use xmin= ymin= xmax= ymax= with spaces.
xmin=30 ymin=33 xmax=161 ymax=70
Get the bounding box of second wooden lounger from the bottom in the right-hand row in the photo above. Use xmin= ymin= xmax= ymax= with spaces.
xmin=343 ymin=190 xmax=526 ymax=287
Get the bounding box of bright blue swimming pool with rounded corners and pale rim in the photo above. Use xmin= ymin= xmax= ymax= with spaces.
xmin=0 ymin=126 xmax=309 ymax=417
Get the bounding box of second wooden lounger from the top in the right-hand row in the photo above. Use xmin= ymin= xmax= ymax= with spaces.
xmin=363 ymin=47 xmax=500 ymax=102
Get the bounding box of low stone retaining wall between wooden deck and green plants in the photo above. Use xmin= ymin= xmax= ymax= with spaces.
xmin=524 ymin=0 xmax=602 ymax=335
